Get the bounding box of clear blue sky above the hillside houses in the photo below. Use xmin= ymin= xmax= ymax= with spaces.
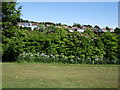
xmin=18 ymin=2 xmax=118 ymax=28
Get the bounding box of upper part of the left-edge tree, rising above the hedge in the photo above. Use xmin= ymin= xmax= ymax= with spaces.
xmin=2 ymin=2 xmax=22 ymax=29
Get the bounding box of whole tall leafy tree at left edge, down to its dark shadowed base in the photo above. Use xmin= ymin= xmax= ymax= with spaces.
xmin=2 ymin=2 xmax=22 ymax=61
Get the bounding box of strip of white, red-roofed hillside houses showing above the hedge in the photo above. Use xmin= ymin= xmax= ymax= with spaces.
xmin=18 ymin=22 xmax=114 ymax=34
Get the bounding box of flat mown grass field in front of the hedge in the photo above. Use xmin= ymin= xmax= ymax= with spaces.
xmin=2 ymin=63 xmax=118 ymax=88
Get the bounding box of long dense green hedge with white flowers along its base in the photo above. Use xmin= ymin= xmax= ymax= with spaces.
xmin=2 ymin=28 xmax=120 ymax=64
